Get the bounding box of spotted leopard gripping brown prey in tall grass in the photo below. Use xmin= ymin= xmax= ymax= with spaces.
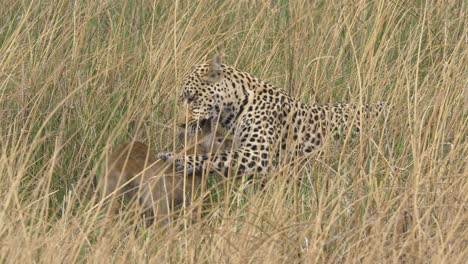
xmin=159 ymin=55 xmax=385 ymax=176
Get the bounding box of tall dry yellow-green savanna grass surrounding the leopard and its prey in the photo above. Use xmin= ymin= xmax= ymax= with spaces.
xmin=0 ymin=0 xmax=468 ymax=263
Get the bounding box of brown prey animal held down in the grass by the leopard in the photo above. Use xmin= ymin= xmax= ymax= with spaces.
xmin=99 ymin=118 xmax=232 ymax=226
